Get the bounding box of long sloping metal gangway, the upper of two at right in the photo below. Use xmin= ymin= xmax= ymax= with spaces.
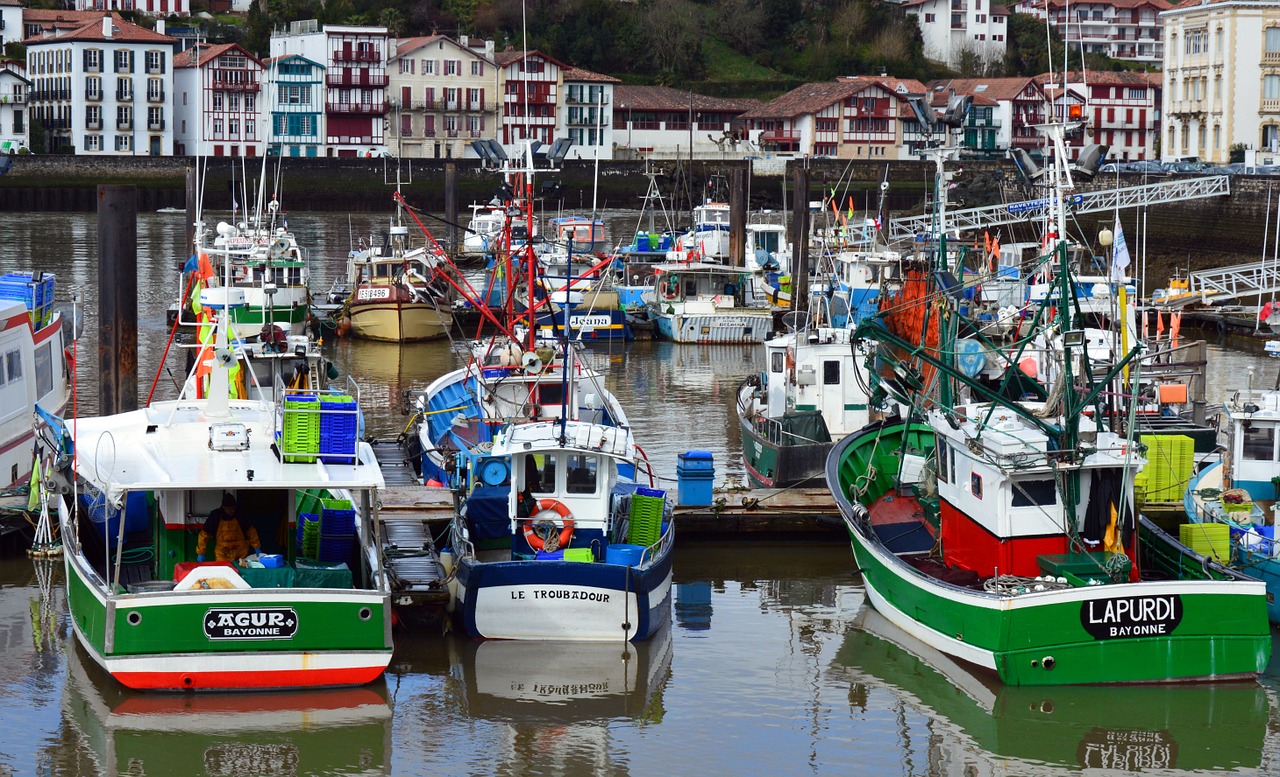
xmin=890 ymin=175 xmax=1231 ymax=242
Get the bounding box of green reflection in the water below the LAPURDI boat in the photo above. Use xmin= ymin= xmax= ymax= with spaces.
xmin=832 ymin=605 xmax=1276 ymax=774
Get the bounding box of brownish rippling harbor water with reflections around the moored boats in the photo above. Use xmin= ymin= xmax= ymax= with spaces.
xmin=0 ymin=214 xmax=1280 ymax=776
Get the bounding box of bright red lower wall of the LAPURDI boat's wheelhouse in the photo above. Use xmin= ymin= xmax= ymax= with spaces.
xmin=940 ymin=499 xmax=1066 ymax=577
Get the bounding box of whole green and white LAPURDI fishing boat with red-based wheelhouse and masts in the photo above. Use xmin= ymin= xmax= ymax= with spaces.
xmin=827 ymin=112 xmax=1271 ymax=685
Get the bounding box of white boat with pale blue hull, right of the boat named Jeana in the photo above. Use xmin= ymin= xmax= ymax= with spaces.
xmin=643 ymin=261 xmax=773 ymax=343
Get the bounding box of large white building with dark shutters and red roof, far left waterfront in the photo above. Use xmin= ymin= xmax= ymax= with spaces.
xmin=26 ymin=17 xmax=174 ymax=156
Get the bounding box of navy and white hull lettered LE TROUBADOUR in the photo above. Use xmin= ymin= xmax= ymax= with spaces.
xmin=457 ymin=550 xmax=672 ymax=641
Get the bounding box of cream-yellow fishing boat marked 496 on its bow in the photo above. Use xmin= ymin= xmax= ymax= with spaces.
xmin=339 ymin=200 xmax=453 ymax=343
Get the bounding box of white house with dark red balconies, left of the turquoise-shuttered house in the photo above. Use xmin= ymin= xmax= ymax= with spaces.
xmin=173 ymin=44 xmax=266 ymax=156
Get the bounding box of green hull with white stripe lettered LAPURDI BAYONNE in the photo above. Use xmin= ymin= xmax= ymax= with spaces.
xmin=827 ymin=421 xmax=1271 ymax=685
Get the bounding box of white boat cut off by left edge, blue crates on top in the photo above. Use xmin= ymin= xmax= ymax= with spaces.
xmin=0 ymin=273 xmax=70 ymax=490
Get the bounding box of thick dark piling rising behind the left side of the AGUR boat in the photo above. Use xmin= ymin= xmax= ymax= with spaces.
xmin=97 ymin=186 xmax=138 ymax=415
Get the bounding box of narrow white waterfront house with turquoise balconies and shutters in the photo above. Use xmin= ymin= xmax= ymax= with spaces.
xmin=265 ymin=54 xmax=326 ymax=156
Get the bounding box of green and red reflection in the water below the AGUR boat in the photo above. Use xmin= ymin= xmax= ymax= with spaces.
xmin=63 ymin=645 xmax=392 ymax=774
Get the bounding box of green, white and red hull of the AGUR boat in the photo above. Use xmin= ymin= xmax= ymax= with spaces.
xmin=64 ymin=553 xmax=392 ymax=691
